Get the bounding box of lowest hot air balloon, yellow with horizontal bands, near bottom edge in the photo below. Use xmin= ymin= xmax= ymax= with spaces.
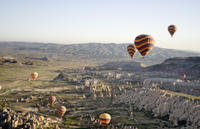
xmin=99 ymin=113 xmax=111 ymax=126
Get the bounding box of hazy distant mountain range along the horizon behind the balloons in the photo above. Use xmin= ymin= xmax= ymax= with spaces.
xmin=0 ymin=42 xmax=200 ymax=65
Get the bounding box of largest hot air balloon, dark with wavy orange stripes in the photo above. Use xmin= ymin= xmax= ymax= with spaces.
xmin=135 ymin=34 xmax=155 ymax=57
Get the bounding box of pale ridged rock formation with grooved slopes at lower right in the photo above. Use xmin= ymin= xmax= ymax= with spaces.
xmin=116 ymin=88 xmax=200 ymax=129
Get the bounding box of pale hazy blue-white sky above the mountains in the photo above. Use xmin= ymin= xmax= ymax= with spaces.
xmin=0 ymin=0 xmax=200 ymax=52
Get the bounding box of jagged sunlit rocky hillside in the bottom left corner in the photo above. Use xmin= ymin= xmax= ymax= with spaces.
xmin=0 ymin=108 xmax=60 ymax=129
